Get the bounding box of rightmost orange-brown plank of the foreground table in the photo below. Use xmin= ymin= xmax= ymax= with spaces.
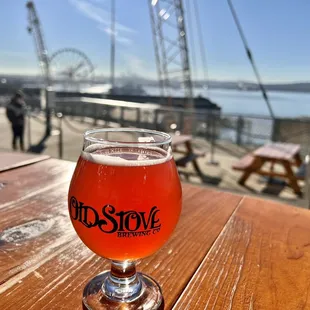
xmin=173 ymin=198 xmax=310 ymax=310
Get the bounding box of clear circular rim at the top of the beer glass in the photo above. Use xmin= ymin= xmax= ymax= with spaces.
xmin=83 ymin=127 xmax=172 ymax=146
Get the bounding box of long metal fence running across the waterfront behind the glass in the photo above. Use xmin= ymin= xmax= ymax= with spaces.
xmin=15 ymin=97 xmax=310 ymax=160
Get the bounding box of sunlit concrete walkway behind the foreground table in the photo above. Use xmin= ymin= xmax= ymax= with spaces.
xmin=0 ymin=108 xmax=305 ymax=206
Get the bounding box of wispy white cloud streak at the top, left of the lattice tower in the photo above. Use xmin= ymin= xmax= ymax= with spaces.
xmin=69 ymin=0 xmax=135 ymax=44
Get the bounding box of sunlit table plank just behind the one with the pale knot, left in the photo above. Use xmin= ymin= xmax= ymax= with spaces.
xmin=0 ymin=159 xmax=75 ymax=210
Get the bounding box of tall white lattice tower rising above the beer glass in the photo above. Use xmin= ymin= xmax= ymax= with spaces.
xmin=147 ymin=0 xmax=194 ymax=109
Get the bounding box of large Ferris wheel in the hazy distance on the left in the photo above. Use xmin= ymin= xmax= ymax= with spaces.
xmin=49 ymin=48 xmax=94 ymax=90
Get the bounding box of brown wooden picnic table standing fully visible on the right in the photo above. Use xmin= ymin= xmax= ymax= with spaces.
xmin=233 ymin=143 xmax=303 ymax=195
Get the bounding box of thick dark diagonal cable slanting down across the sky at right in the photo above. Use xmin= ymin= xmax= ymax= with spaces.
xmin=227 ymin=0 xmax=275 ymax=119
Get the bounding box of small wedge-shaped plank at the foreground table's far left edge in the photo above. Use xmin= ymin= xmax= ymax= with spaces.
xmin=0 ymin=152 xmax=49 ymax=172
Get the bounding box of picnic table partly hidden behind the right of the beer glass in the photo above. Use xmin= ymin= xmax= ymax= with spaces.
xmin=171 ymin=134 xmax=205 ymax=178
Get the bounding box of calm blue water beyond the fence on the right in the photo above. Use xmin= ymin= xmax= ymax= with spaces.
xmin=142 ymin=88 xmax=310 ymax=144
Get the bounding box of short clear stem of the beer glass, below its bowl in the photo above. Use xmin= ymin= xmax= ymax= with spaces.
xmin=102 ymin=261 xmax=142 ymax=301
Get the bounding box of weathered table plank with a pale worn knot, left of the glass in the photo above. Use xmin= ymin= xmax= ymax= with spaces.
xmin=0 ymin=185 xmax=76 ymax=292
